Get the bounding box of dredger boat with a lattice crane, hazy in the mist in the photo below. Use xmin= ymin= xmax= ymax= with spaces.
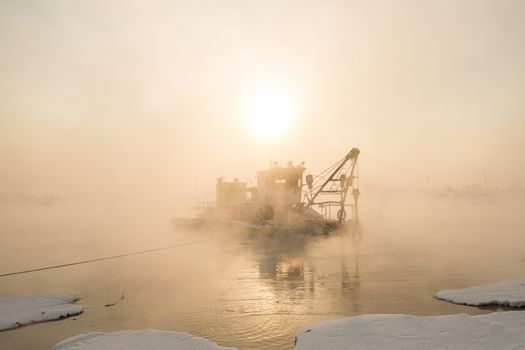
xmin=173 ymin=148 xmax=360 ymax=234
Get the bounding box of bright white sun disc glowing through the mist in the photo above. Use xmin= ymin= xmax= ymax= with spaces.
xmin=243 ymin=87 xmax=295 ymax=140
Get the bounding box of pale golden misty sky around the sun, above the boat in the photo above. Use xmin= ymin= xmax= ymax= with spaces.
xmin=0 ymin=0 xmax=525 ymax=194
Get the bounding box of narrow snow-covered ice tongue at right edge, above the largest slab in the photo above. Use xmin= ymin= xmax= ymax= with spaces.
xmin=435 ymin=280 xmax=525 ymax=307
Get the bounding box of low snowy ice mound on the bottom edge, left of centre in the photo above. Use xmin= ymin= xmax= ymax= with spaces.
xmin=51 ymin=330 xmax=235 ymax=350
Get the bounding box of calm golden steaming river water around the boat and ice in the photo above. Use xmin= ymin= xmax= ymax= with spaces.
xmin=0 ymin=195 xmax=525 ymax=350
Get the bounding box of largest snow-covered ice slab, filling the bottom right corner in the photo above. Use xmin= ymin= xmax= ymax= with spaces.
xmin=295 ymin=311 xmax=525 ymax=350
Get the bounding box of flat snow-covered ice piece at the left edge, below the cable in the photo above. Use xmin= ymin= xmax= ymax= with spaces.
xmin=0 ymin=294 xmax=82 ymax=331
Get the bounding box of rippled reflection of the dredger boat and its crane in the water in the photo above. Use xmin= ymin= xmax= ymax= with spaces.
xmin=238 ymin=226 xmax=363 ymax=315
